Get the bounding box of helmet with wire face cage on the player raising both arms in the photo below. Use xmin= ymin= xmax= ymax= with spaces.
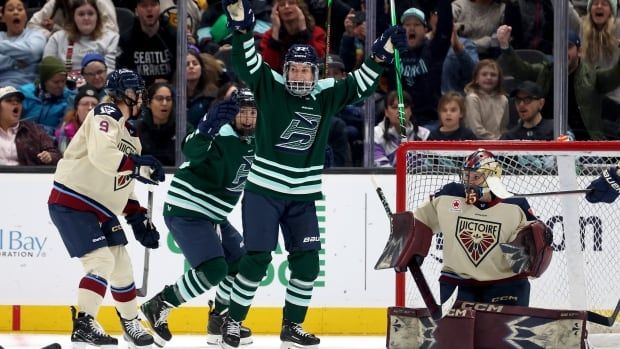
xmin=284 ymin=44 xmax=319 ymax=96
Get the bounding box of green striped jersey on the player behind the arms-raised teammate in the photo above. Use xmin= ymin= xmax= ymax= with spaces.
xmin=164 ymin=124 xmax=254 ymax=223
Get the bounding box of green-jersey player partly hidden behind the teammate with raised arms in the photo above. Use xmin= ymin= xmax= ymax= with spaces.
xmin=140 ymin=89 xmax=257 ymax=347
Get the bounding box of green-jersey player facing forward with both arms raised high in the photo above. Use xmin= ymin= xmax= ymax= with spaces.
xmin=221 ymin=0 xmax=406 ymax=348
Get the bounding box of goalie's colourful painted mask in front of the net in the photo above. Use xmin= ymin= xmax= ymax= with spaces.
xmin=462 ymin=149 xmax=512 ymax=204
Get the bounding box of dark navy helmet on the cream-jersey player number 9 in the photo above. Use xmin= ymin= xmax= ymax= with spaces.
xmin=105 ymin=69 xmax=146 ymax=107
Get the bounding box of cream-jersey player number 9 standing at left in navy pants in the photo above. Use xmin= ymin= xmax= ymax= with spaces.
xmin=48 ymin=69 xmax=164 ymax=348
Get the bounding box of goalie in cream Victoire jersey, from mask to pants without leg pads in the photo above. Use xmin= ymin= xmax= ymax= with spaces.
xmin=392 ymin=149 xmax=552 ymax=306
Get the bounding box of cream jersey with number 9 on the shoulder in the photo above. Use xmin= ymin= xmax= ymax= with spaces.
xmin=48 ymin=103 xmax=142 ymax=222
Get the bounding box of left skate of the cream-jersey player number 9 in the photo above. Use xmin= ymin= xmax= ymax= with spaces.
xmin=71 ymin=307 xmax=118 ymax=349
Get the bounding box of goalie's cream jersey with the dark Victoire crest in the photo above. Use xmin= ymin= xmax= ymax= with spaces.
xmin=414 ymin=183 xmax=536 ymax=281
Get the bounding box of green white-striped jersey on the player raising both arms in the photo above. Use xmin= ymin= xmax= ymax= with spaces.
xmin=232 ymin=33 xmax=383 ymax=201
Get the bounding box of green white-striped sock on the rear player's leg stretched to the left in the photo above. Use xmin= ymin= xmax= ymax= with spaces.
xmin=163 ymin=257 xmax=228 ymax=307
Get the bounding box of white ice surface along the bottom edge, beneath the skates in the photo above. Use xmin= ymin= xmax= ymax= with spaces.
xmin=0 ymin=333 xmax=620 ymax=349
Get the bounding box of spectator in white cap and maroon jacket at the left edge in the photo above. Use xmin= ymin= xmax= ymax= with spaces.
xmin=0 ymin=86 xmax=60 ymax=166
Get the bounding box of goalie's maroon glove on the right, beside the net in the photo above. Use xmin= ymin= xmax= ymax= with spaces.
xmin=500 ymin=221 xmax=553 ymax=277
